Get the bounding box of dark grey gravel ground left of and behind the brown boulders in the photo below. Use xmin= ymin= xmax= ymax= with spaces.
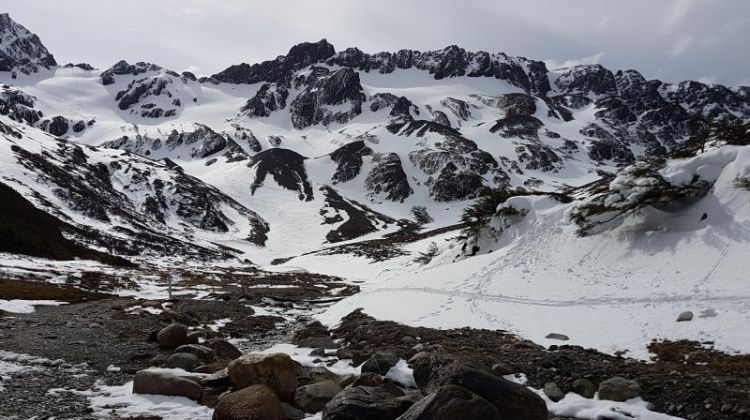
xmin=0 ymin=276 xmax=350 ymax=419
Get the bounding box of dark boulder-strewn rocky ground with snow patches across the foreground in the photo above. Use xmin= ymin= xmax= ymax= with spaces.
xmin=0 ymin=276 xmax=750 ymax=420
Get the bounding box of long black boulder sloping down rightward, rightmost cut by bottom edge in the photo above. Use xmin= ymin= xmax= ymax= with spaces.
xmin=409 ymin=353 xmax=548 ymax=420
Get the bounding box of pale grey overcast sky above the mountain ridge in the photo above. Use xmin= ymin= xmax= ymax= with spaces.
xmin=5 ymin=0 xmax=750 ymax=85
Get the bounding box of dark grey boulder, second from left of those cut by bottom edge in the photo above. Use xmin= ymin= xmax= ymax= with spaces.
xmin=323 ymin=386 xmax=412 ymax=420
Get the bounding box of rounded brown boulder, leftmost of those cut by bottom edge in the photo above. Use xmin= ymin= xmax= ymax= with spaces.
xmin=212 ymin=385 xmax=286 ymax=420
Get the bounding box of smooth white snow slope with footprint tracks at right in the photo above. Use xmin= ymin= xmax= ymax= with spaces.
xmin=316 ymin=147 xmax=750 ymax=358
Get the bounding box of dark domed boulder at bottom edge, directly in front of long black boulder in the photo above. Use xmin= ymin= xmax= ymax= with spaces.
xmin=398 ymin=385 xmax=501 ymax=420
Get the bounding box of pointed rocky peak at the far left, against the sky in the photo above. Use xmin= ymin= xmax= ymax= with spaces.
xmin=0 ymin=13 xmax=57 ymax=74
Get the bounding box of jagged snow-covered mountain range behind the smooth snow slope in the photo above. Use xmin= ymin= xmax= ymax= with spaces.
xmin=0 ymin=15 xmax=750 ymax=262
